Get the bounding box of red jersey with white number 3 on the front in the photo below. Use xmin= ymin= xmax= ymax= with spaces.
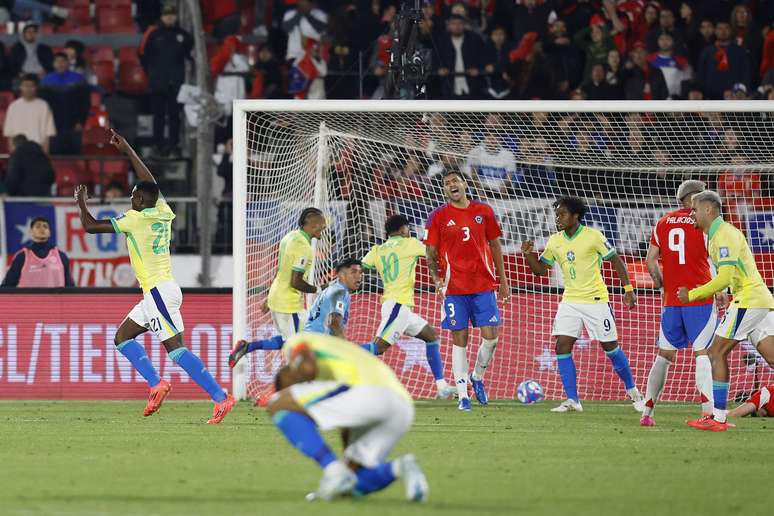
xmin=424 ymin=201 xmax=502 ymax=295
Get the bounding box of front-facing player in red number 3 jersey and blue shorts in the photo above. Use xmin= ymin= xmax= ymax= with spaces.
xmin=425 ymin=170 xmax=510 ymax=411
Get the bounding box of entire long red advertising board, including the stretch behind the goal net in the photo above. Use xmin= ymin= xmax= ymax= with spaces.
xmin=0 ymin=292 xmax=771 ymax=400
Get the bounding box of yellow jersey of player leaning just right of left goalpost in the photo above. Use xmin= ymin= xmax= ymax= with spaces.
xmin=267 ymin=229 xmax=312 ymax=314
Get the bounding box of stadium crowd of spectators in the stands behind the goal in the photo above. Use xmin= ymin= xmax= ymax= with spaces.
xmin=0 ymin=0 xmax=774 ymax=252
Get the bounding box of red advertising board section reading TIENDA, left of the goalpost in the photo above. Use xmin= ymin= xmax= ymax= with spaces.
xmin=0 ymin=292 xmax=232 ymax=399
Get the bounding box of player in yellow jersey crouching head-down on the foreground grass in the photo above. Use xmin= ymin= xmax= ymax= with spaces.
xmin=267 ymin=332 xmax=428 ymax=501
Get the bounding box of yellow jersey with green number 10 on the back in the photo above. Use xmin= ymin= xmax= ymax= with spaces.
xmin=362 ymin=235 xmax=425 ymax=306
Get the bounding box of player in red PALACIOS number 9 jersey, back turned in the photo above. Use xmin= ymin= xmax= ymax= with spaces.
xmin=638 ymin=180 xmax=725 ymax=426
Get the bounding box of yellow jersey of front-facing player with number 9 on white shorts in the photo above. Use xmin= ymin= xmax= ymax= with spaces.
xmin=540 ymin=224 xmax=616 ymax=304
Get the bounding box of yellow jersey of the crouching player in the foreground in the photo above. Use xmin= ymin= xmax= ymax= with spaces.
xmin=282 ymin=333 xmax=411 ymax=405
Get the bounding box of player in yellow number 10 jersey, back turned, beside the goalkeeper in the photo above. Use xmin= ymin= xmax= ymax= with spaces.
xmin=362 ymin=215 xmax=454 ymax=398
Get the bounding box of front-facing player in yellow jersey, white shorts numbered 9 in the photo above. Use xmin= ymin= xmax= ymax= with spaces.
xmin=521 ymin=197 xmax=642 ymax=412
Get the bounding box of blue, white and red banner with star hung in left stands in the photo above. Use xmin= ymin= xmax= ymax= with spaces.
xmin=3 ymin=202 xmax=136 ymax=287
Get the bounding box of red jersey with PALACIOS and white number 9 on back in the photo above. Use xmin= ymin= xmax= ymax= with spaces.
xmin=650 ymin=208 xmax=713 ymax=306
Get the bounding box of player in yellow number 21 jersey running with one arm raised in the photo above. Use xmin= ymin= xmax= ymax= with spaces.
xmin=75 ymin=130 xmax=236 ymax=425
